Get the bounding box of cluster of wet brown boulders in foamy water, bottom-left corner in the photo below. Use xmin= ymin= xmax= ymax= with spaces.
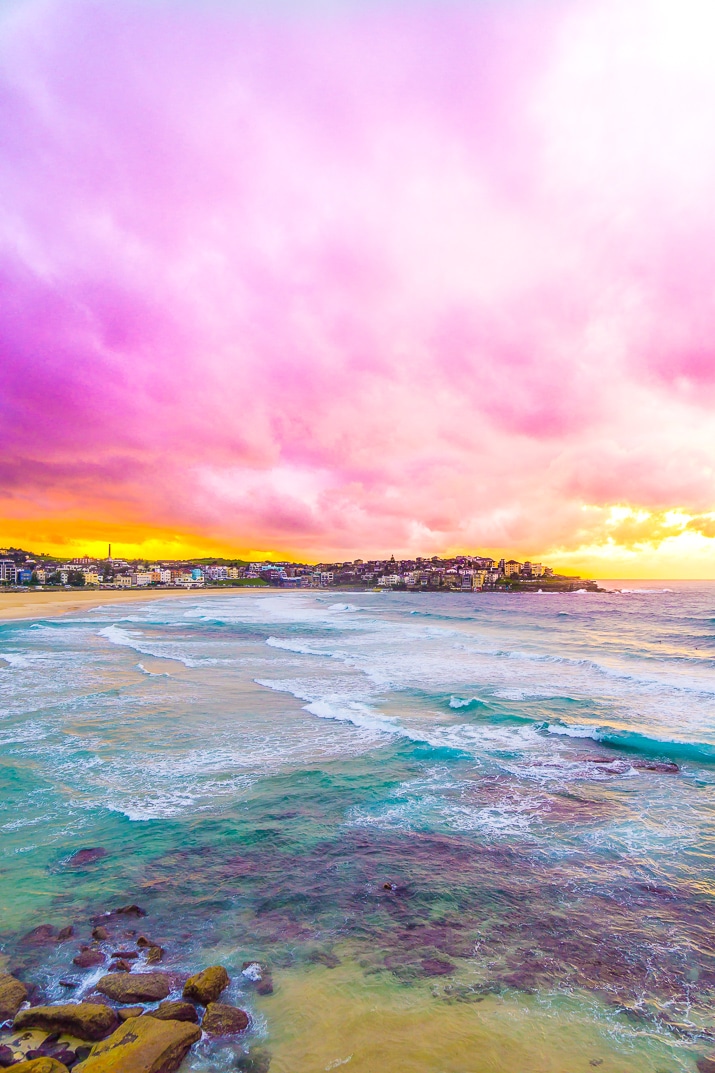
xmin=0 ymin=906 xmax=273 ymax=1073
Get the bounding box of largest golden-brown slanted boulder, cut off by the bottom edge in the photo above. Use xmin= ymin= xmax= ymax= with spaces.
xmin=73 ymin=1017 xmax=201 ymax=1073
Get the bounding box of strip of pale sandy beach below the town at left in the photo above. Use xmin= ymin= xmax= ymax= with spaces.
xmin=0 ymin=587 xmax=247 ymax=622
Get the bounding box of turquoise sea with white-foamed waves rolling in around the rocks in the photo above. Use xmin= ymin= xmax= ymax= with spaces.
xmin=0 ymin=583 xmax=715 ymax=1073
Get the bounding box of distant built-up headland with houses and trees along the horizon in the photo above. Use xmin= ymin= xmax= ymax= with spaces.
xmin=0 ymin=545 xmax=598 ymax=592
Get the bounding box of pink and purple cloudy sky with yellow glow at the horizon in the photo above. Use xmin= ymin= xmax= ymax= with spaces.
xmin=0 ymin=0 xmax=715 ymax=578
